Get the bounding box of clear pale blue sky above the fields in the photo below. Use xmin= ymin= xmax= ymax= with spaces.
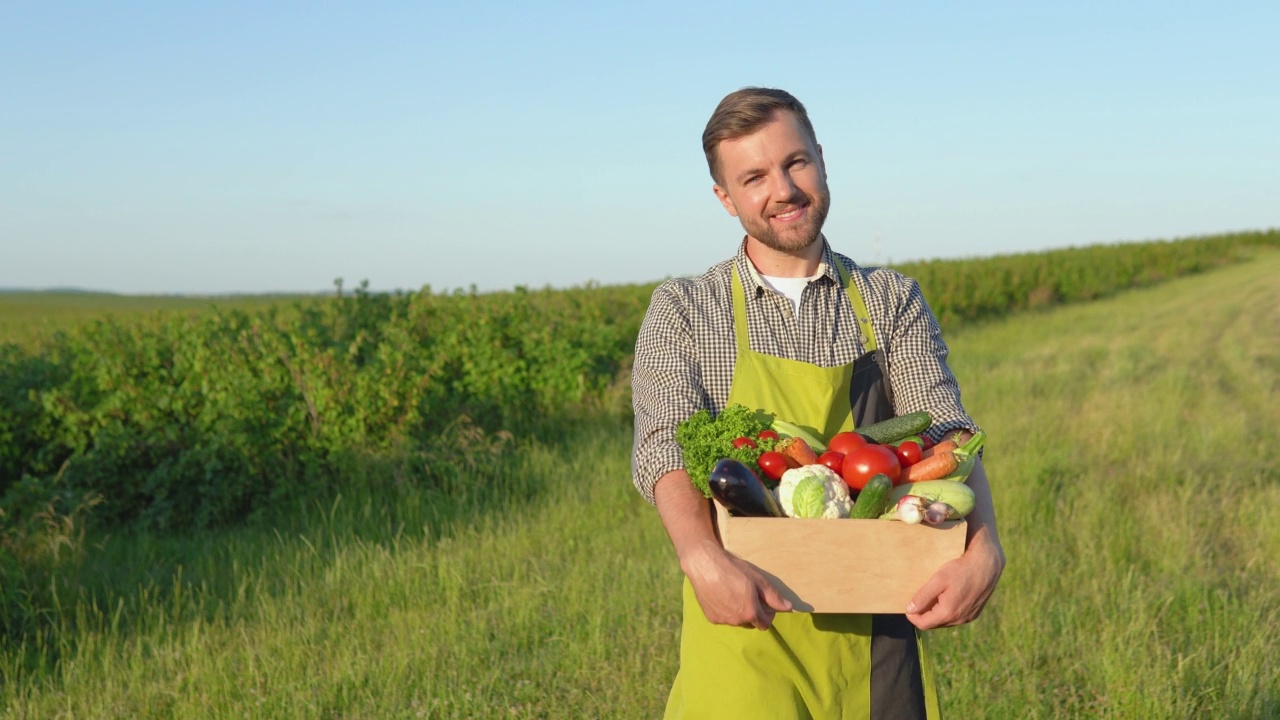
xmin=0 ymin=0 xmax=1280 ymax=293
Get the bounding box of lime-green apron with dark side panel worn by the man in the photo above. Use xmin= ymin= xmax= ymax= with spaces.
xmin=666 ymin=261 xmax=938 ymax=720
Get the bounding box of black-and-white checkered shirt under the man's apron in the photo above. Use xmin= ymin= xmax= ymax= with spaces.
xmin=631 ymin=238 xmax=978 ymax=502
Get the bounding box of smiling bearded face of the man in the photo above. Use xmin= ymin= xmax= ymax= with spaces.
xmin=714 ymin=111 xmax=831 ymax=252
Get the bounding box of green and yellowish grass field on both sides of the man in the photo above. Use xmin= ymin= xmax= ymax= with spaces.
xmin=0 ymin=252 xmax=1280 ymax=719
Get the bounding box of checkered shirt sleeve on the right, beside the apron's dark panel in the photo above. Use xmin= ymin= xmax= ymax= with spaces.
xmin=877 ymin=270 xmax=978 ymax=439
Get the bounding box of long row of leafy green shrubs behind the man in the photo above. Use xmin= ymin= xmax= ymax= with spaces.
xmin=0 ymin=231 xmax=1280 ymax=528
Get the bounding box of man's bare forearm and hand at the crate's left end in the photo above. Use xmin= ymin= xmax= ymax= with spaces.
xmin=653 ymin=470 xmax=791 ymax=630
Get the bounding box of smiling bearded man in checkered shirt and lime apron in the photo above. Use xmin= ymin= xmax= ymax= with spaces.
xmin=632 ymin=87 xmax=1005 ymax=720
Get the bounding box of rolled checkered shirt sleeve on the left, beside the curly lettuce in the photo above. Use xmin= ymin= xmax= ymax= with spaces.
xmin=631 ymin=279 xmax=708 ymax=502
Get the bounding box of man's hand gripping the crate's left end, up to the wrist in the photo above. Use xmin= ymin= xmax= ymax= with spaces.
xmin=680 ymin=535 xmax=791 ymax=630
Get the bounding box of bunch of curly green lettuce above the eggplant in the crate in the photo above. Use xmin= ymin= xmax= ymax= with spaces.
xmin=676 ymin=405 xmax=773 ymax=497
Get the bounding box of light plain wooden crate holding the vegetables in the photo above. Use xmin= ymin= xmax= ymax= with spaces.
xmin=716 ymin=502 xmax=968 ymax=612
